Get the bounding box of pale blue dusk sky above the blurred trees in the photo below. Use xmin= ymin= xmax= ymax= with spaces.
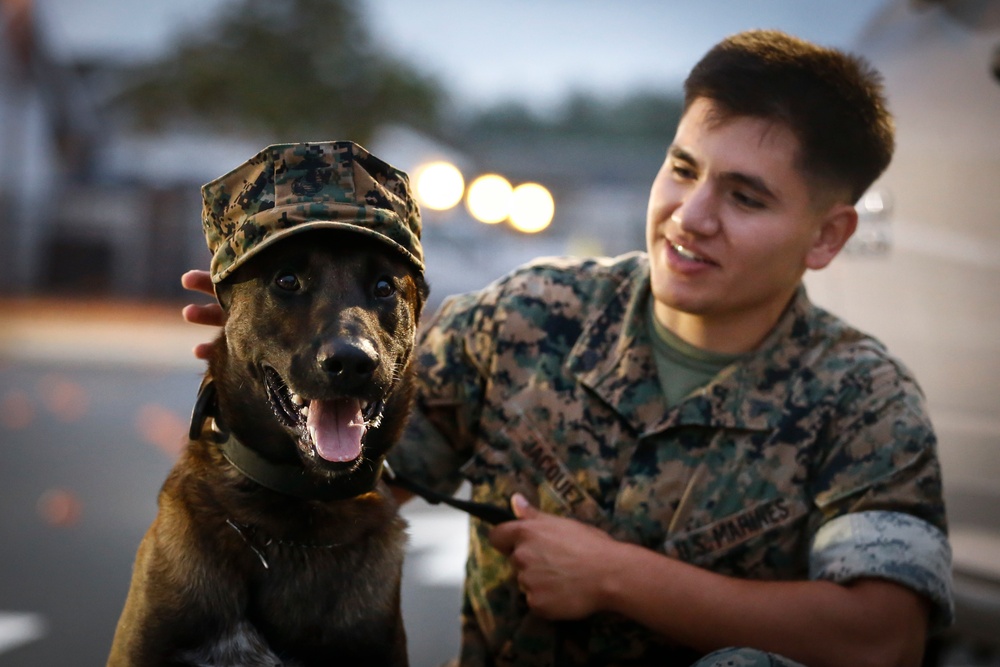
xmin=36 ymin=0 xmax=891 ymax=109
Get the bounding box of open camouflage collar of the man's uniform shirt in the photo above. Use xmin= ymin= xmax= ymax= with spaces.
xmin=567 ymin=264 xmax=812 ymax=437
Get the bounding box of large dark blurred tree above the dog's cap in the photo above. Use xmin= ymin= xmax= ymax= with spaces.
xmin=111 ymin=0 xmax=443 ymax=142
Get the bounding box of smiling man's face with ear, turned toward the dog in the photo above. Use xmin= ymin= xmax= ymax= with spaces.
xmin=646 ymin=98 xmax=853 ymax=348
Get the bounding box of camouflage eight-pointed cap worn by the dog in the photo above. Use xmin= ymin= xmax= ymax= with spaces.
xmin=201 ymin=141 xmax=424 ymax=283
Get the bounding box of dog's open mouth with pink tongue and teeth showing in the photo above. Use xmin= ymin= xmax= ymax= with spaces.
xmin=264 ymin=366 xmax=385 ymax=463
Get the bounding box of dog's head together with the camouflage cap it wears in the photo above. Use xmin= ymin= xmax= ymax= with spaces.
xmin=202 ymin=142 xmax=427 ymax=496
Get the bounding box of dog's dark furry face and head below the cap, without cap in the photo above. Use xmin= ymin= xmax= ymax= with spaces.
xmin=210 ymin=231 xmax=427 ymax=488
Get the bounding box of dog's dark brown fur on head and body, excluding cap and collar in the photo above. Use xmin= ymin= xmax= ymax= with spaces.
xmin=108 ymin=230 xmax=426 ymax=667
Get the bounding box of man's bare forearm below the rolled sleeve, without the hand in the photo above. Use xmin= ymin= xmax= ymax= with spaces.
xmin=601 ymin=543 xmax=928 ymax=667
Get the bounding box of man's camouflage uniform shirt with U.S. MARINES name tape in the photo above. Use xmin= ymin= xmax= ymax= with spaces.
xmin=390 ymin=253 xmax=951 ymax=667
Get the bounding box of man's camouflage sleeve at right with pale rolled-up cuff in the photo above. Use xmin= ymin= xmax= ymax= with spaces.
xmin=809 ymin=344 xmax=954 ymax=630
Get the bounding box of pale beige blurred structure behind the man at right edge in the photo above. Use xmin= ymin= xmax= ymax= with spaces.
xmin=808 ymin=0 xmax=1000 ymax=641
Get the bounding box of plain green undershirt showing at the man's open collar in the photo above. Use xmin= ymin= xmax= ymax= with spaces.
xmin=647 ymin=299 xmax=742 ymax=408
